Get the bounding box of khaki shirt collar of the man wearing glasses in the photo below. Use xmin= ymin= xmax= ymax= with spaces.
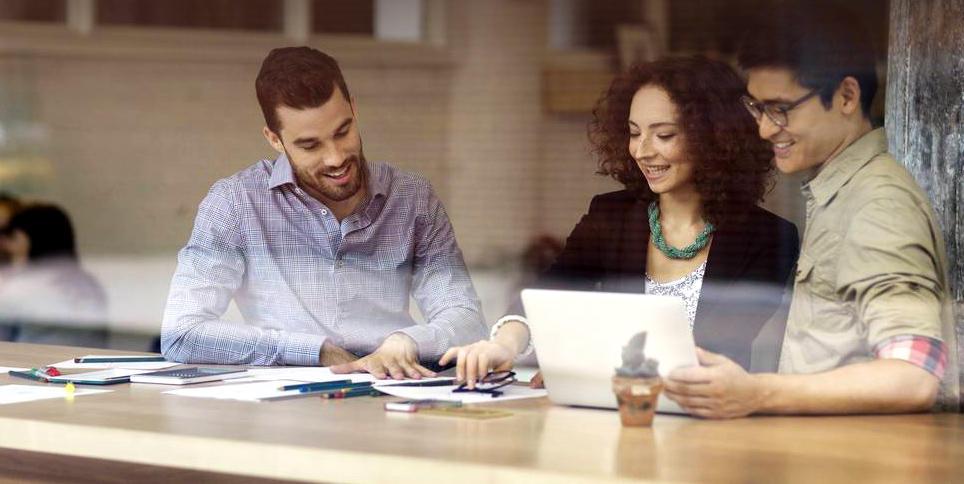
xmin=804 ymin=128 xmax=887 ymax=205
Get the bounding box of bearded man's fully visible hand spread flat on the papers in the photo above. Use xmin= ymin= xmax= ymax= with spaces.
xmin=331 ymin=333 xmax=435 ymax=380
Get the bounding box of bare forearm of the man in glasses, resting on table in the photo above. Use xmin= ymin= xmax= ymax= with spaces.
xmin=754 ymin=359 xmax=940 ymax=414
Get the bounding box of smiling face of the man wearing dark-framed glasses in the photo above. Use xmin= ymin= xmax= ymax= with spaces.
xmin=747 ymin=68 xmax=851 ymax=173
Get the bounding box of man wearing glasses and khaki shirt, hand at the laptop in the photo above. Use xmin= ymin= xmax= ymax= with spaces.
xmin=666 ymin=0 xmax=959 ymax=418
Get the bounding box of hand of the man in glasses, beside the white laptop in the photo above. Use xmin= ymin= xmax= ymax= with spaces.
xmin=664 ymin=348 xmax=764 ymax=418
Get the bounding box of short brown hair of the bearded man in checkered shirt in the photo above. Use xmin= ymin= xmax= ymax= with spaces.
xmin=254 ymin=46 xmax=351 ymax=136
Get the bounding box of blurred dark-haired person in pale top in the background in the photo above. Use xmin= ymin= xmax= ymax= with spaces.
xmin=0 ymin=204 xmax=107 ymax=347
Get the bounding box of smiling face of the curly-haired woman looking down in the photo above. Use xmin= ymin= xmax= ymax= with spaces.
xmin=629 ymin=86 xmax=696 ymax=195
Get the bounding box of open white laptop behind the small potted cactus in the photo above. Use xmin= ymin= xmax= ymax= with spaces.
xmin=522 ymin=289 xmax=699 ymax=413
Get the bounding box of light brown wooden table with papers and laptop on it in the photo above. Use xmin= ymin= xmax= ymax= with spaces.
xmin=0 ymin=343 xmax=964 ymax=484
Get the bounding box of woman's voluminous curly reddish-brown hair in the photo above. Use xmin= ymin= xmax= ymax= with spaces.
xmin=589 ymin=56 xmax=773 ymax=225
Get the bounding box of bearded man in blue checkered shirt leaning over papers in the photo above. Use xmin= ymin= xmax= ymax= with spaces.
xmin=161 ymin=47 xmax=486 ymax=378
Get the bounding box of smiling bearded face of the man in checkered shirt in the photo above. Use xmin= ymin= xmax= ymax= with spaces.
xmin=264 ymin=89 xmax=366 ymax=211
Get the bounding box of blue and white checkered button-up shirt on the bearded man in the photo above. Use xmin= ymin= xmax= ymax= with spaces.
xmin=161 ymin=155 xmax=487 ymax=365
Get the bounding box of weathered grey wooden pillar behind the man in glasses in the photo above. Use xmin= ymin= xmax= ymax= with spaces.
xmin=886 ymin=0 xmax=964 ymax=410
